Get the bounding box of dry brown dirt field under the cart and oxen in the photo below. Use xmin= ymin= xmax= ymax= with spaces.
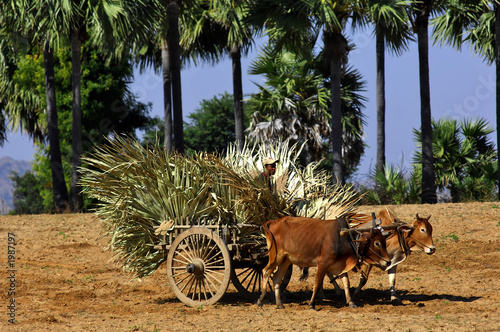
xmin=0 ymin=203 xmax=500 ymax=332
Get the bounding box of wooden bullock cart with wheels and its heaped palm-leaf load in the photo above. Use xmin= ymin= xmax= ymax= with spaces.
xmin=80 ymin=136 xmax=359 ymax=306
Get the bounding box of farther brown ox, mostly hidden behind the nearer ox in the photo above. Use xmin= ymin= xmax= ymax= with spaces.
xmin=346 ymin=209 xmax=436 ymax=301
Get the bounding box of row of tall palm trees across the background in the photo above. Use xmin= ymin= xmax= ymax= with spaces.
xmin=0 ymin=0 xmax=500 ymax=211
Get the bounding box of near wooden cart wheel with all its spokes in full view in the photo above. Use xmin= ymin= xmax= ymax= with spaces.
xmin=167 ymin=227 xmax=231 ymax=307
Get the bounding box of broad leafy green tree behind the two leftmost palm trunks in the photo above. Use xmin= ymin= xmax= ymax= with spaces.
xmin=6 ymin=44 xmax=151 ymax=212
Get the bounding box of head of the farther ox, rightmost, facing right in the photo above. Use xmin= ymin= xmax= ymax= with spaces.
xmin=400 ymin=213 xmax=436 ymax=255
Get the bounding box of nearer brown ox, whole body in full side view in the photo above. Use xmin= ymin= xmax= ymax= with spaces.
xmin=257 ymin=217 xmax=389 ymax=309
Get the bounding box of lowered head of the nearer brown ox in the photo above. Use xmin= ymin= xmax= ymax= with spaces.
xmin=356 ymin=228 xmax=391 ymax=269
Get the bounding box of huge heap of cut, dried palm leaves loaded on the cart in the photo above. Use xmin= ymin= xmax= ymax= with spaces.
xmin=81 ymin=137 xmax=359 ymax=277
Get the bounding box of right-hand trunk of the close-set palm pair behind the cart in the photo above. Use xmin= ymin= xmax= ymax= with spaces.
xmin=167 ymin=0 xmax=184 ymax=153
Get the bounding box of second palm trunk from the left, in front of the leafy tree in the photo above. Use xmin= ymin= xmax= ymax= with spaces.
xmin=69 ymin=29 xmax=83 ymax=212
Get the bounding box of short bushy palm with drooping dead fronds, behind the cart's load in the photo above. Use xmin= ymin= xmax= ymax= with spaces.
xmin=248 ymin=44 xmax=366 ymax=175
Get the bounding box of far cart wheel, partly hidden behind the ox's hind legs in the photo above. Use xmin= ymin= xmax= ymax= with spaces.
xmin=231 ymin=262 xmax=293 ymax=301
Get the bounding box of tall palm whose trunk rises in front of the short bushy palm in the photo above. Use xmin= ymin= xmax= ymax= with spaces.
xmin=252 ymin=0 xmax=363 ymax=183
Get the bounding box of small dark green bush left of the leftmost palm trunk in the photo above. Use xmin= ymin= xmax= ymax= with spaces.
xmin=10 ymin=171 xmax=46 ymax=214
